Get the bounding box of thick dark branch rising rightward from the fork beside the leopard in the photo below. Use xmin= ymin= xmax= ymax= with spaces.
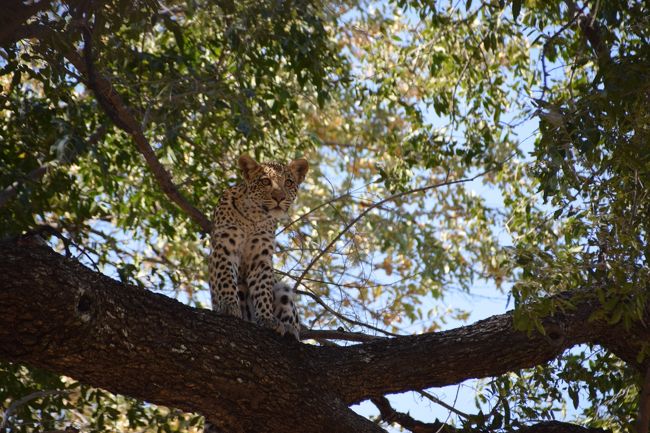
xmin=317 ymin=292 xmax=650 ymax=404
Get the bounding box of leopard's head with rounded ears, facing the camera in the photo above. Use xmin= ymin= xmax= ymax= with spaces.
xmin=239 ymin=155 xmax=309 ymax=218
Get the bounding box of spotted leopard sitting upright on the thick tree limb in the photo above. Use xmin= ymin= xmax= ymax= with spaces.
xmin=208 ymin=154 xmax=309 ymax=340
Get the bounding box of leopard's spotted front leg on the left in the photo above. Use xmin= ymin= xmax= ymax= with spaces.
xmin=209 ymin=229 xmax=242 ymax=319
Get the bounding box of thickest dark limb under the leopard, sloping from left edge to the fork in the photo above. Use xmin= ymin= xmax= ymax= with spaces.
xmin=0 ymin=242 xmax=382 ymax=432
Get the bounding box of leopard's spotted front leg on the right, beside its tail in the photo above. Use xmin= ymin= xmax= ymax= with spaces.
xmin=246 ymin=238 xmax=285 ymax=335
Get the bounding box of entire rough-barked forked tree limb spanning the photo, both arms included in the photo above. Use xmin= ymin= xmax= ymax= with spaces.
xmin=0 ymin=241 xmax=647 ymax=433
